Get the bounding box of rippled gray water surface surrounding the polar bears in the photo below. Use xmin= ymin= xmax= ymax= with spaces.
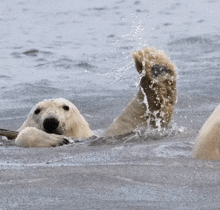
xmin=0 ymin=0 xmax=220 ymax=210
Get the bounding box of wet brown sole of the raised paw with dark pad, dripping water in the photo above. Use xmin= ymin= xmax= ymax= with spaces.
xmin=133 ymin=47 xmax=177 ymax=127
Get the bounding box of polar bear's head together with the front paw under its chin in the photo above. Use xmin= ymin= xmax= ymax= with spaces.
xmin=15 ymin=98 xmax=94 ymax=147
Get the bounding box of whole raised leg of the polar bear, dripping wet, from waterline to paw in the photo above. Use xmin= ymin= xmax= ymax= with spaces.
xmin=105 ymin=47 xmax=177 ymax=136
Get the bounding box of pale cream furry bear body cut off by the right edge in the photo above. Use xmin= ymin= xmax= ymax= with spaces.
xmin=194 ymin=104 xmax=220 ymax=160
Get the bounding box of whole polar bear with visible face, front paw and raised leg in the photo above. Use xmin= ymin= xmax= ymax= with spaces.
xmin=5 ymin=47 xmax=177 ymax=147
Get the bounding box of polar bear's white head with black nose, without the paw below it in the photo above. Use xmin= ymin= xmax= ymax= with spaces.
xmin=18 ymin=98 xmax=93 ymax=138
